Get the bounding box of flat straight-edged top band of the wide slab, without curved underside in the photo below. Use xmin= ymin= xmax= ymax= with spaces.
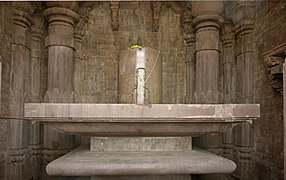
xmin=25 ymin=103 xmax=260 ymax=122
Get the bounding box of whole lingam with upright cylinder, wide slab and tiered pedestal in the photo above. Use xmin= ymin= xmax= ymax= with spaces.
xmin=25 ymin=47 xmax=260 ymax=179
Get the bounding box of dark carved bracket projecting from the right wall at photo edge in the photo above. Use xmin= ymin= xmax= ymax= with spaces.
xmin=263 ymin=43 xmax=286 ymax=96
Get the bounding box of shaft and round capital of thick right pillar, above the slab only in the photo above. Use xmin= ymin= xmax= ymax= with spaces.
xmin=193 ymin=14 xmax=223 ymax=103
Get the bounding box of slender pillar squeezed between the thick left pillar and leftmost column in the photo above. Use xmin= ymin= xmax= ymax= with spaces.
xmin=29 ymin=14 xmax=44 ymax=179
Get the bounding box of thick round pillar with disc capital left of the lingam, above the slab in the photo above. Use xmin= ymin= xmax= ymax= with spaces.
xmin=44 ymin=7 xmax=79 ymax=102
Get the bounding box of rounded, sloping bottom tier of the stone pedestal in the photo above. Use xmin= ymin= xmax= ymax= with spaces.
xmin=46 ymin=147 xmax=236 ymax=176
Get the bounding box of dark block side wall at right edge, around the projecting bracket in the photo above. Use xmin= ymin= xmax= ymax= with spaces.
xmin=253 ymin=1 xmax=286 ymax=180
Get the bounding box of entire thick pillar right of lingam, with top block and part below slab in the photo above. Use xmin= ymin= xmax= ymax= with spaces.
xmin=192 ymin=1 xmax=224 ymax=154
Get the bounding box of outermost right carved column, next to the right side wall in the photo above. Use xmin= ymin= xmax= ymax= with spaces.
xmin=226 ymin=1 xmax=256 ymax=179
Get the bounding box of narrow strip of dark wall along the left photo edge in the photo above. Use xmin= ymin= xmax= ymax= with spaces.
xmin=0 ymin=3 xmax=13 ymax=179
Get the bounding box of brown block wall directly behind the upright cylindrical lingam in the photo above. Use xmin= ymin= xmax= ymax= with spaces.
xmin=82 ymin=2 xmax=185 ymax=103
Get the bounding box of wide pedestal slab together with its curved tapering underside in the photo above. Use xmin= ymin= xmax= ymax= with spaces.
xmin=25 ymin=103 xmax=260 ymax=137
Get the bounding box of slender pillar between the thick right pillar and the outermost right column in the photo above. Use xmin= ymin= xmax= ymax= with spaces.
xmin=222 ymin=22 xmax=235 ymax=159
